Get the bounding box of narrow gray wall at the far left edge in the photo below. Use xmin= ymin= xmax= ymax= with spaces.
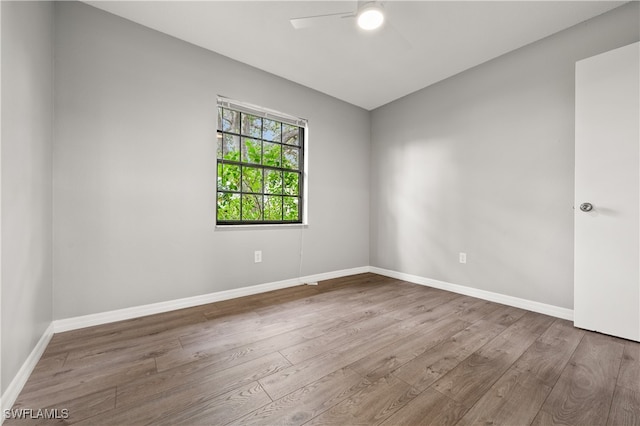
xmin=0 ymin=1 xmax=53 ymax=393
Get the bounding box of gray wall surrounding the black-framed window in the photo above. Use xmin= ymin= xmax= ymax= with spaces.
xmin=54 ymin=2 xmax=370 ymax=319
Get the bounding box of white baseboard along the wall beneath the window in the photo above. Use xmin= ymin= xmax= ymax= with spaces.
xmin=53 ymin=266 xmax=369 ymax=333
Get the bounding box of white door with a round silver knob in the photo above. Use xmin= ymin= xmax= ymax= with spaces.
xmin=574 ymin=43 xmax=640 ymax=341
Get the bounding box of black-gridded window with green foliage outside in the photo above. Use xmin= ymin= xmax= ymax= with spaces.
xmin=216 ymin=98 xmax=306 ymax=225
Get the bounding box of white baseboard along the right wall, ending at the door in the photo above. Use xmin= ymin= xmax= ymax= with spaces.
xmin=369 ymin=266 xmax=573 ymax=321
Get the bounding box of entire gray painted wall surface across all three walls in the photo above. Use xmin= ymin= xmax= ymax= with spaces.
xmin=0 ymin=2 xmax=640 ymax=391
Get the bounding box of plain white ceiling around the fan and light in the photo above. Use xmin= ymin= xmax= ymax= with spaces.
xmin=86 ymin=1 xmax=625 ymax=110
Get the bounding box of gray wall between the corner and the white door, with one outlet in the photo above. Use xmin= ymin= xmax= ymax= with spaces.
xmin=370 ymin=2 xmax=640 ymax=308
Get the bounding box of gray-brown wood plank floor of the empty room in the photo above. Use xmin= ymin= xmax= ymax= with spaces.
xmin=5 ymin=274 xmax=640 ymax=425
